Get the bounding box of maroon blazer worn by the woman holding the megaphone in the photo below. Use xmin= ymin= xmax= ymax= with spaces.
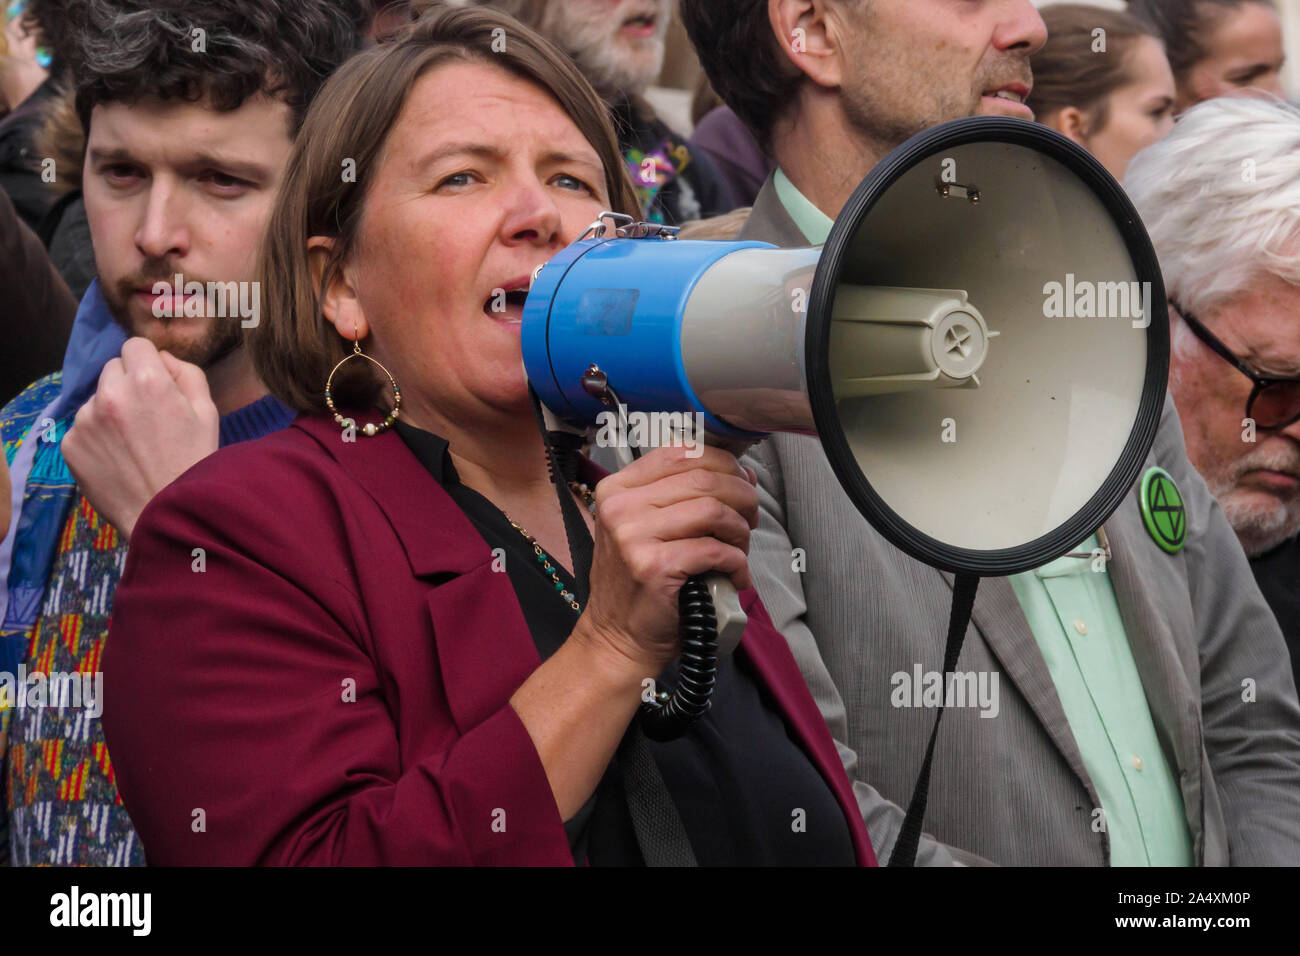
xmin=103 ymin=416 xmax=875 ymax=866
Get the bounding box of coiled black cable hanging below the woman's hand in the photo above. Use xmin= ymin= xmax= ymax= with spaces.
xmin=641 ymin=576 xmax=718 ymax=741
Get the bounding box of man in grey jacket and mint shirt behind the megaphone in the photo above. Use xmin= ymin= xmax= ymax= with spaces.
xmin=681 ymin=0 xmax=1300 ymax=865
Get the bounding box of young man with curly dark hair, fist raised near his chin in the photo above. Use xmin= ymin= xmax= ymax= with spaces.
xmin=0 ymin=0 xmax=365 ymax=865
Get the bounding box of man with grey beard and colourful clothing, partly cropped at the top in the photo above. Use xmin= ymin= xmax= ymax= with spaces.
xmin=436 ymin=0 xmax=738 ymax=225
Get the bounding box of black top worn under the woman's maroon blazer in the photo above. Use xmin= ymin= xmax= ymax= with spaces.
xmin=395 ymin=421 xmax=855 ymax=866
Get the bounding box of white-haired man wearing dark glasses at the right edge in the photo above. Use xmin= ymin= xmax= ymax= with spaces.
xmin=1125 ymin=99 xmax=1300 ymax=697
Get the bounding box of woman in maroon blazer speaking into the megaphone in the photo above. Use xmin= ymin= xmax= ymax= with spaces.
xmin=104 ymin=8 xmax=874 ymax=865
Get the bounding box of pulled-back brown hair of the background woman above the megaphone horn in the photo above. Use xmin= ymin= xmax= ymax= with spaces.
xmin=1026 ymin=4 xmax=1160 ymax=135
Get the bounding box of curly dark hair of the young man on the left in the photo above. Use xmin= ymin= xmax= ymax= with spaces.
xmin=61 ymin=0 xmax=373 ymax=133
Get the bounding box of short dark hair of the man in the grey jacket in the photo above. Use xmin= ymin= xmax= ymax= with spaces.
xmin=680 ymin=0 xmax=803 ymax=151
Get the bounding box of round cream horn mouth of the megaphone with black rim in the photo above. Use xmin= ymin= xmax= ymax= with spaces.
xmin=806 ymin=117 xmax=1169 ymax=576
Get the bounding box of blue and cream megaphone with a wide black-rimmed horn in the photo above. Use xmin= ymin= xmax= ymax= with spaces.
xmin=521 ymin=117 xmax=1169 ymax=738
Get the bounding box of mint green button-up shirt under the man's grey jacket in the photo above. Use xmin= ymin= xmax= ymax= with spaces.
xmin=774 ymin=169 xmax=1195 ymax=866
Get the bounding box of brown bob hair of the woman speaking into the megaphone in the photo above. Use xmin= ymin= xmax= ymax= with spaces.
xmin=248 ymin=8 xmax=641 ymax=412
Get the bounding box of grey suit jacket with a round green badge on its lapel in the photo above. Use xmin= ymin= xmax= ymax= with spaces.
xmin=741 ymin=179 xmax=1300 ymax=866
